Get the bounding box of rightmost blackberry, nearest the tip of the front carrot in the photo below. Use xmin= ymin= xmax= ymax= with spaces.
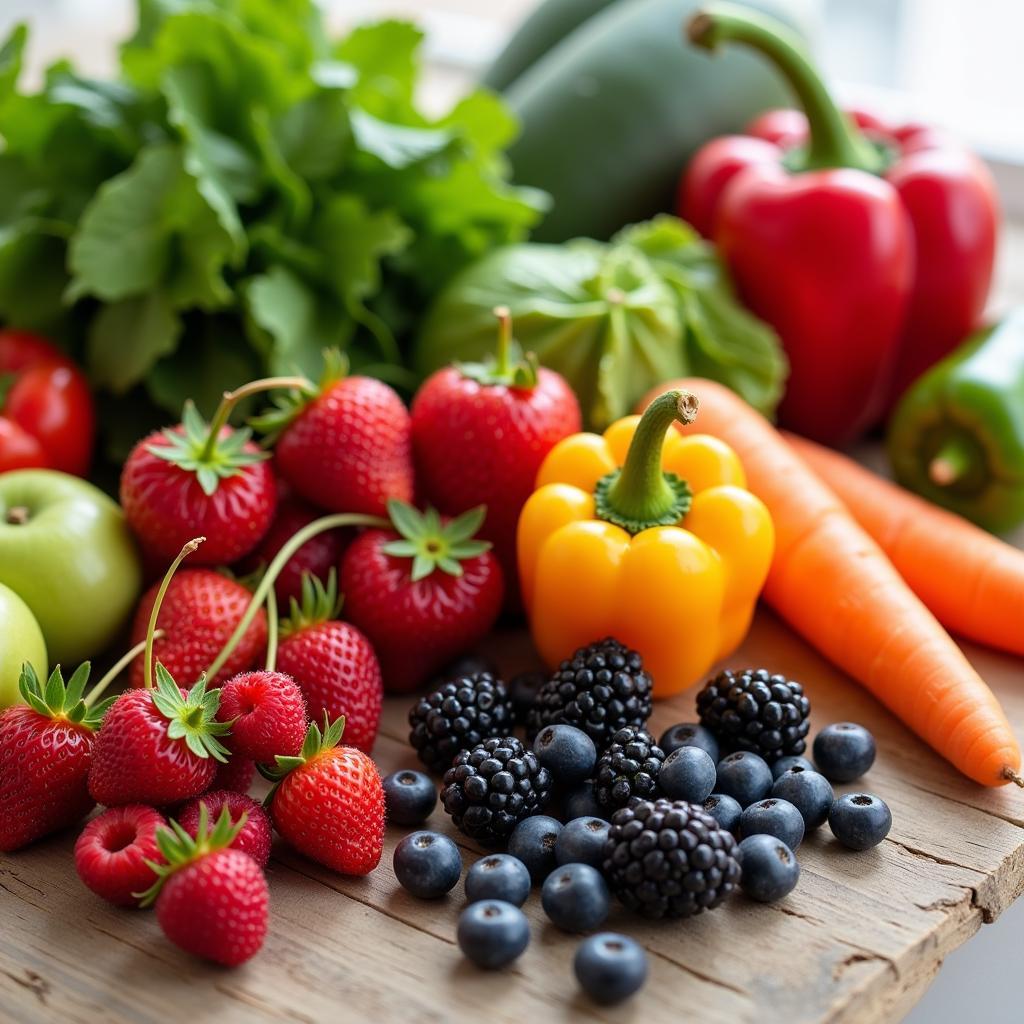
xmin=697 ymin=669 xmax=811 ymax=764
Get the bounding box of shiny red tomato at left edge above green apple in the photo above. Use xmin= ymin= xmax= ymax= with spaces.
xmin=0 ymin=330 xmax=95 ymax=476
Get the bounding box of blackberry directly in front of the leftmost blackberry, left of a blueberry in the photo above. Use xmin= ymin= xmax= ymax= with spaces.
xmin=441 ymin=736 xmax=551 ymax=845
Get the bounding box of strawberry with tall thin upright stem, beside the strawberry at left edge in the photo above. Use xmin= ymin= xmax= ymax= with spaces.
xmin=89 ymin=538 xmax=230 ymax=807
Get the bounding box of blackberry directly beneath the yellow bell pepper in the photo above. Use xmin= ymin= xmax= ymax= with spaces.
xmin=526 ymin=637 xmax=653 ymax=749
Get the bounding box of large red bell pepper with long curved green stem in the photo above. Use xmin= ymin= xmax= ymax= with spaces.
xmin=678 ymin=4 xmax=998 ymax=444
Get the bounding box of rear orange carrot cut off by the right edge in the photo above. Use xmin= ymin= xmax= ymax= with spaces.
xmin=782 ymin=432 xmax=1024 ymax=654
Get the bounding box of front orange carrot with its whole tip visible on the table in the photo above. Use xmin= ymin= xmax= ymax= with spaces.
xmin=644 ymin=379 xmax=1024 ymax=785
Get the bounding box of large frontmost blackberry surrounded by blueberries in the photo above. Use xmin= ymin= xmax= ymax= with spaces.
xmin=603 ymin=800 xmax=741 ymax=918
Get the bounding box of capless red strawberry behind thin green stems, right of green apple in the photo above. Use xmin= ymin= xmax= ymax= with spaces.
xmin=130 ymin=569 xmax=266 ymax=687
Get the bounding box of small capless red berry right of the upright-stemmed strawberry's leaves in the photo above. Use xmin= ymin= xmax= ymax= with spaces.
xmin=217 ymin=672 xmax=308 ymax=762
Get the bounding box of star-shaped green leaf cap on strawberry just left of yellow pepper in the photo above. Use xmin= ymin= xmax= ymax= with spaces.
xmin=382 ymin=498 xmax=490 ymax=583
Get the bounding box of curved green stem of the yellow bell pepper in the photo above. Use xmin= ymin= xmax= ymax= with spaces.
xmin=594 ymin=391 xmax=699 ymax=534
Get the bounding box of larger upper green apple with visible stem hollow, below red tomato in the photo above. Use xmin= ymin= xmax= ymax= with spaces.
xmin=0 ymin=469 xmax=142 ymax=671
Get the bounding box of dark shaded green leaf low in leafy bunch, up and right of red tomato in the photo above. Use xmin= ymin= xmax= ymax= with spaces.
xmin=86 ymin=290 xmax=181 ymax=397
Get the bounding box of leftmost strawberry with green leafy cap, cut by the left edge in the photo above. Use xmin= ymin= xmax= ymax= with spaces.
xmin=0 ymin=663 xmax=112 ymax=852
